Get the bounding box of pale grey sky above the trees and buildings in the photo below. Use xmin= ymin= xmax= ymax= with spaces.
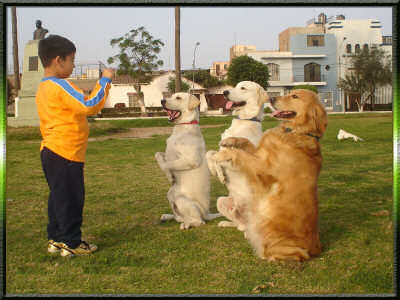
xmin=6 ymin=5 xmax=392 ymax=70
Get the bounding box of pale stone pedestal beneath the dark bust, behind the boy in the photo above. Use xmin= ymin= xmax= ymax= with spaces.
xmin=7 ymin=40 xmax=44 ymax=127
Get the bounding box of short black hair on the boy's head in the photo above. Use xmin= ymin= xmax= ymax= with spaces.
xmin=39 ymin=35 xmax=76 ymax=68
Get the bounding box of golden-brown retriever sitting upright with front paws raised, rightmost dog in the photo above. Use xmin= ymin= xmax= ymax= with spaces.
xmin=214 ymin=89 xmax=328 ymax=261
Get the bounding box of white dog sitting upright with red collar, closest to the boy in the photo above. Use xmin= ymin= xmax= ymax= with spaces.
xmin=155 ymin=93 xmax=221 ymax=229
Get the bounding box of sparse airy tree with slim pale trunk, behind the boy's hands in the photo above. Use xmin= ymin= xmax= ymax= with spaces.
xmin=107 ymin=26 xmax=164 ymax=113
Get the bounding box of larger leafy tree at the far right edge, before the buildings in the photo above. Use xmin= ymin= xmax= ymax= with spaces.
xmin=351 ymin=48 xmax=392 ymax=109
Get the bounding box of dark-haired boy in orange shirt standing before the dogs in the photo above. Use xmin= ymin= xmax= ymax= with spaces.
xmin=36 ymin=35 xmax=113 ymax=256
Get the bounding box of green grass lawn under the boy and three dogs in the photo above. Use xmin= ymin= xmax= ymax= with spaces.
xmin=5 ymin=114 xmax=394 ymax=294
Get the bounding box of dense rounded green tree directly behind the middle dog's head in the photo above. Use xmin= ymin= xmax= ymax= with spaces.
xmin=227 ymin=55 xmax=270 ymax=89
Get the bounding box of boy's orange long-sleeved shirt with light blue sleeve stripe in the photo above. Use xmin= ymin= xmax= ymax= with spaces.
xmin=36 ymin=77 xmax=111 ymax=162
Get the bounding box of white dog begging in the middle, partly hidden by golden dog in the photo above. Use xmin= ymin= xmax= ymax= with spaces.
xmin=207 ymin=81 xmax=269 ymax=231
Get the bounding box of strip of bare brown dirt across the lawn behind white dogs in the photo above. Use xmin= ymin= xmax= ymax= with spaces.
xmin=88 ymin=124 xmax=224 ymax=142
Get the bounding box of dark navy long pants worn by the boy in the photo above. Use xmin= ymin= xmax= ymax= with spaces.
xmin=40 ymin=147 xmax=85 ymax=248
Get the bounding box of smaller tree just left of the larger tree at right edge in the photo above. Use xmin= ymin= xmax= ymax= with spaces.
xmin=337 ymin=74 xmax=367 ymax=111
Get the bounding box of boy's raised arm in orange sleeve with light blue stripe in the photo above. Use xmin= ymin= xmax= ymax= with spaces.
xmin=57 ymin=76 xmax=111 ymax=116
